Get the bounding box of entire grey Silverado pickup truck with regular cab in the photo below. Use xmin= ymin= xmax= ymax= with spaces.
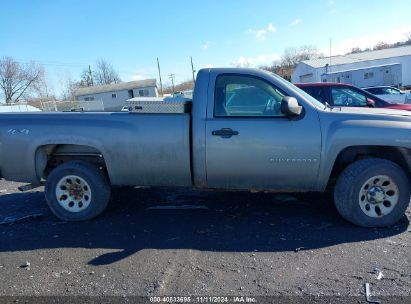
xmin=0 ymin=69 xmax=411 ymax=227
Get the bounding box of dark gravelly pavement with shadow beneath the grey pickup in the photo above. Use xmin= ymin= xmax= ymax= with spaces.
xmin=0 ymin=181 xmax=411 ymax=298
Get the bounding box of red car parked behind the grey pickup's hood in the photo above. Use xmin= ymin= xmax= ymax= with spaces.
xmin=296 ymin=82 xmax=411 ymax=111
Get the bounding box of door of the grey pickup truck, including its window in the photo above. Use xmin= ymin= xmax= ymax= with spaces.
xmin=206 ymin=74 xmax=321 ymax=190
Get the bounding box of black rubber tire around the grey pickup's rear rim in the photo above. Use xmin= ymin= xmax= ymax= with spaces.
xmin=45 ymin=161 xmax=111 ymax=221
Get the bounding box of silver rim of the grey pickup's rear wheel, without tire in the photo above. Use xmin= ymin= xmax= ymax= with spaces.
xmin=56 ymin=175 xmax=91 ymax=212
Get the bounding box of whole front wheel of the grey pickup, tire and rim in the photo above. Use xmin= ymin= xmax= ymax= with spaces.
xmin=334 ymin=158 xmax=410 ymax=227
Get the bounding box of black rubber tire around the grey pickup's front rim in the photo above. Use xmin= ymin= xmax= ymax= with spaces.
xmin=334 ymin=158 xmax=410 ymax=227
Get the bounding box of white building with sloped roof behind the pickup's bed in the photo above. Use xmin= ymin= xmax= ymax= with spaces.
xmin=74 ymin=79 xmax=158 ymax=111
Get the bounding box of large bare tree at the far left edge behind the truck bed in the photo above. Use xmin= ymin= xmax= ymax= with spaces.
xmin=0 ymin=57 xmax=45 ymax=103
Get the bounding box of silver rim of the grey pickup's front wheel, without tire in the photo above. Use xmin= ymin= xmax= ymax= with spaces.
xmin=358 ymin=175 xmax=399 ymax=218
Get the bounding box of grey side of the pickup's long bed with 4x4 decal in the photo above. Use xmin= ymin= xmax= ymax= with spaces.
xmin=0 ymin=112 xmax=191 ymax=186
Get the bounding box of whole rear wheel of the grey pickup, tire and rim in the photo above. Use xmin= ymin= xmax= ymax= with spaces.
xmin=45 ymin=161 xmax=110 ymax=221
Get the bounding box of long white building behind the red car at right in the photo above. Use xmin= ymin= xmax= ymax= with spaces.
xmin=291 ymin=46 xmax=411 ymax=87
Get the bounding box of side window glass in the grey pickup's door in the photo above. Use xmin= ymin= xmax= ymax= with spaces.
xmin=214 ymin=75 xmax=285 ymax=117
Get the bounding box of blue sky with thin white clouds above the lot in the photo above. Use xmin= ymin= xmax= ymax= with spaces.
xmin=0 ymin=0 xmax=411 ymax=94
